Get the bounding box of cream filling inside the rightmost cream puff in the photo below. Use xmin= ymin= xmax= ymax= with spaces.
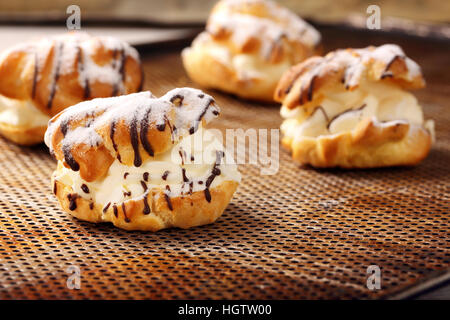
xmin=281 ymin=81 xmax=434 ymax=137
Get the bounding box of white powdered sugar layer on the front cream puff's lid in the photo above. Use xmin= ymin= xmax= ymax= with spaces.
xmin=45 ymin=88 xmax=219 ymax=151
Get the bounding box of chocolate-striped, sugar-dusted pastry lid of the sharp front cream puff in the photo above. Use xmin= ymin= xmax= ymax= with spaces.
xmin=45 ymin=88 xmax=220 ymax=182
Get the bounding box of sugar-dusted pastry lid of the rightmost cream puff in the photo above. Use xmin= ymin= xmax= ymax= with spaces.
xmin=274 ymin=44 xmax=425 ymax=109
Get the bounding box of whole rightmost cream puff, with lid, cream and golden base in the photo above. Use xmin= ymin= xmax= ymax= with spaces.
xmin=275 ymin=44 xmax=434 ymax=168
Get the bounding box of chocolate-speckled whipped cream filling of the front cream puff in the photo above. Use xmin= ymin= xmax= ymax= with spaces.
xmin=55 ymin=128 xmax=241 ymax=207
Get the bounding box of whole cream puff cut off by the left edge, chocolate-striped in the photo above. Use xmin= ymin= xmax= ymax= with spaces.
xmin=0 ymin=32 xmax=143 ymax=145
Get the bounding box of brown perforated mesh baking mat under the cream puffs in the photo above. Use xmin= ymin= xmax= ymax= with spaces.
xmin=0 ymin=53 xmax=450 ymax=299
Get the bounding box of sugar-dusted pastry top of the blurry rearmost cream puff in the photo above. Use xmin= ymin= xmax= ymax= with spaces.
xmin=196 ymin=0 xmax=320 ymax=63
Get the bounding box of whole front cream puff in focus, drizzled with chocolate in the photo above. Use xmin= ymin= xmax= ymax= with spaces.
xmin=45 ymin=88 xmax=241 ymax=231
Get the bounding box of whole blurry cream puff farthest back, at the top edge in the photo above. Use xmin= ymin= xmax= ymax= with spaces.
xmin=182 ymin=0 xmax=320 ymax=102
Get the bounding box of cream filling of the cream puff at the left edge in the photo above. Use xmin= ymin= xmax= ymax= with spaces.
xmin=0 ymin=95 xmax=50 ymax=128
